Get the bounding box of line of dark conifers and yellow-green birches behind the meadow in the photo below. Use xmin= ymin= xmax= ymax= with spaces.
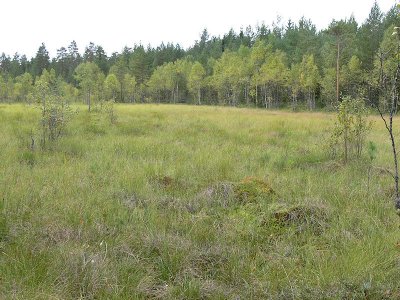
xmin=0 ymin=3 xmax=400 ymax=109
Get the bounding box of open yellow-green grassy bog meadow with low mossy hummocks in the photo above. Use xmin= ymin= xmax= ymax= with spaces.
xmin=0 ymin=104 xmax=400 ymax=299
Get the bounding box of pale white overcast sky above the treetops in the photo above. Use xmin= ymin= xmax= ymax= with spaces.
xmin=0 ymin=0 xmax=396 ymax=57
